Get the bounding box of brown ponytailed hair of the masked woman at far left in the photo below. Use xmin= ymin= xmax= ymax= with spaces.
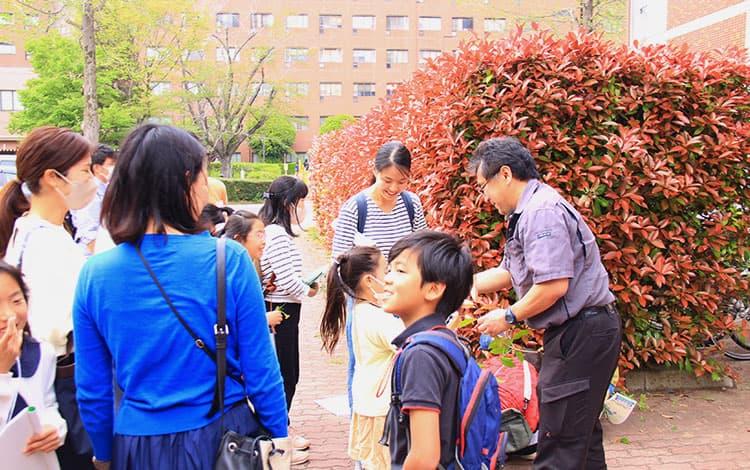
xmin=0 ymin=126 xmax=93 ymax=257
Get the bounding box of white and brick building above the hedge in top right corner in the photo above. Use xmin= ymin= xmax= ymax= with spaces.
xmin=628 ymin=0 xmax=750 ymax=51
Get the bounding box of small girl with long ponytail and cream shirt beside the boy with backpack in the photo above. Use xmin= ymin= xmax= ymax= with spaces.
xmin=320 ymin=246 xmax=404 ymax=470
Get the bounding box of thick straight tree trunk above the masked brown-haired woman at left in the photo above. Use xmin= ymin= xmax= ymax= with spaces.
xmin=81 ymin=0 xmax=99 ymax=143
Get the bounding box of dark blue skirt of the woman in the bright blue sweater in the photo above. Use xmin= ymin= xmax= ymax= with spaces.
xmin=112 ymin=401 xmax=258 ymax=470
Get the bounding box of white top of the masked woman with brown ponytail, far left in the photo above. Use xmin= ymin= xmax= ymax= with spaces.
xmin=5 ymin=215 xmax=85 ymax=356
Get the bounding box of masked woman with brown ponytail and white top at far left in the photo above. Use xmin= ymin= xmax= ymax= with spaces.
xmin=0 ymin=127 xmax=96 ymax=468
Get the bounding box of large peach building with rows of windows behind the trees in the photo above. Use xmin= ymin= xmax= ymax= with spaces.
xmin=0 ymin=0 xmax=579 ymax=161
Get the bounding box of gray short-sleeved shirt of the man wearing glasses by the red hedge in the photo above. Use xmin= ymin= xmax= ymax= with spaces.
xmin=500 ymin=179 xmax=615 ymax=328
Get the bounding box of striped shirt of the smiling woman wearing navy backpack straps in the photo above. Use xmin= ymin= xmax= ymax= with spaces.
xmin=333 ymin=192 xmax=427 ymax=261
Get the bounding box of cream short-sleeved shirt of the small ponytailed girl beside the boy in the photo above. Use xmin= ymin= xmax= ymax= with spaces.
xmin=352 ymin=302 xmax=404 ymax=416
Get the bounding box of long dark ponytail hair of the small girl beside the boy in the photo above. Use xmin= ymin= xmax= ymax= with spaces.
xmin=320 ymin=246 xmax=382 ymax=354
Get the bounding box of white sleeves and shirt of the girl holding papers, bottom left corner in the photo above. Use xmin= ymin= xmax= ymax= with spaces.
xmin=0 ymin=341 xmax=68 ymax=442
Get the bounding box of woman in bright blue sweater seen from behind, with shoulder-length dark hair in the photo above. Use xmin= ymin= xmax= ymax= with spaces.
xmin=73 ymin=125 xmax=287 ymax=469
